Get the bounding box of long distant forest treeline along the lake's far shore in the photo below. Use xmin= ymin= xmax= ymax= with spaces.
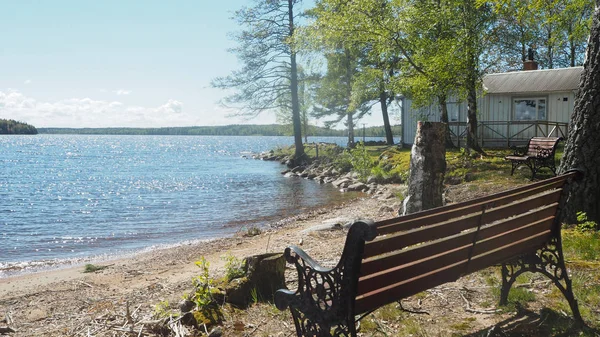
xmin=38 ymin=124 xmax=401 ymax=137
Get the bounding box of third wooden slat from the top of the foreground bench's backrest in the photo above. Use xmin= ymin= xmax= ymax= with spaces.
xmin=360 ymin=203 xmax=558 ymax=275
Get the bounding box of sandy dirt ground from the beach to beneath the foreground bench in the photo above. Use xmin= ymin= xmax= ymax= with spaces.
xmin=0 ymin=182 xmax=592 ymax=337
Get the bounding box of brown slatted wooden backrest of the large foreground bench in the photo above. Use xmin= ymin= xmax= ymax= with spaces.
xmin=355 ymin=173 xmax=575 ymax=314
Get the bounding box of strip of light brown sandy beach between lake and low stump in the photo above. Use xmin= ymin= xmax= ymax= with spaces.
xmin=0 ymin=195 xmax=398 ymax=336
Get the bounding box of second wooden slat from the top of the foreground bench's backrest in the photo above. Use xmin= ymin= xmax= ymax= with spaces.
xmin=363 ymin=189 xmax=562 ymax=258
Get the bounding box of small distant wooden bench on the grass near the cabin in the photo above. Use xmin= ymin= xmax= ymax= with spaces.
xmin=504 ymin=137 xmax=562 ymax=180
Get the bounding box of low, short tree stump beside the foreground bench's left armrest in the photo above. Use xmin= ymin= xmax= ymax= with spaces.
xmin=225 ymin=253 xmax=285 ymax=307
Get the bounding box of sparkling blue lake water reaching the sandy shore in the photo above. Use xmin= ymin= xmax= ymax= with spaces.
xmin=0 ymin=135 xmax=366 ymax=277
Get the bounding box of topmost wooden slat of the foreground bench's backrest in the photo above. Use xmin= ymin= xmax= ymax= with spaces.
xmin=377 ymin=179 xmax=564 ymax=235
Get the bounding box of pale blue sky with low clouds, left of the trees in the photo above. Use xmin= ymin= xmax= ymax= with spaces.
xmin=0 ymin=0 xmax=392 ymax=127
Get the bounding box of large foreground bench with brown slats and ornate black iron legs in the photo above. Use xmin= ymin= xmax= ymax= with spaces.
xmin=275 ymin=171 xmax=583 ymax=336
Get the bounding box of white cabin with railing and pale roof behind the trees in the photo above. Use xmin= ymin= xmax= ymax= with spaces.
xmin=402 ymin=67 xmax=583 ymax=147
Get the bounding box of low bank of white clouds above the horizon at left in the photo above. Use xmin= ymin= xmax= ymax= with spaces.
xmin=0 ymin=90 xmax=195 ymax=128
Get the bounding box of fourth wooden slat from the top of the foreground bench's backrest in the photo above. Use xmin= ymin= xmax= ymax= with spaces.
xmin=357 ymin=216 xmax=554 ymax=295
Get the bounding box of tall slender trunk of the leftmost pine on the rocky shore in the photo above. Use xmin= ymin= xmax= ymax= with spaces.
xmin=288 ymin=0 xmax=306 ymax=165
